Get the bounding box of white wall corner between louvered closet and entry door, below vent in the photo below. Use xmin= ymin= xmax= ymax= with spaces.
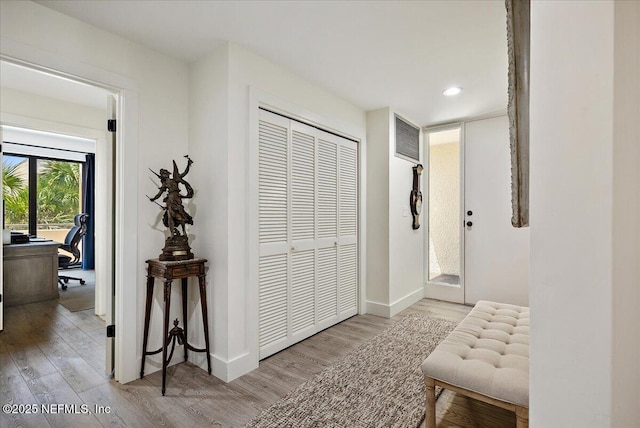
xmin=367 ymin=108 xmax=424 ymax=317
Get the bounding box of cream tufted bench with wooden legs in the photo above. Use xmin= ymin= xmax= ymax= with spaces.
xmin=422 ymin=300 xmax=529 ymax=428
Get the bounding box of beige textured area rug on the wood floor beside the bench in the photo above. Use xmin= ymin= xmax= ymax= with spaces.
xmin=246 ymin=314 xmax=456 ymax=428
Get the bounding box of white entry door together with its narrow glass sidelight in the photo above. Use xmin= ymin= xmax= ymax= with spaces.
xmin=424 ymin=115 xmax=529 ymax=306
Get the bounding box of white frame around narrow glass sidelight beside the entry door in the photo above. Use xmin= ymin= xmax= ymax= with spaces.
xmin=422 ymin=121 xmax=465 ymax=303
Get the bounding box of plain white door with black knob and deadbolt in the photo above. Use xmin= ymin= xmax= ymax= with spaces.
xmin=464 ymin=116 xmax=529 ymax=305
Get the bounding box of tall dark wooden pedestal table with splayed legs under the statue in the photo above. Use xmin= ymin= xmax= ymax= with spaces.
xmin=140 ymin=259 xmax=211 ymax=395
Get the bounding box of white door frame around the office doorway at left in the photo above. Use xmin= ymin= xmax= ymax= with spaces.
xmin=0 ymin=39 xmax=140 ymax=383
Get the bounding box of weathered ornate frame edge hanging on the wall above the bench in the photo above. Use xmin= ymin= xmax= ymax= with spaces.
xmin=505 ymin=0 xmax=530 ymax=227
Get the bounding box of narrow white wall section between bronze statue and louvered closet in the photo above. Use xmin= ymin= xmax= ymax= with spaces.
xmin=189 ymin=46 xmax=229 ymax=377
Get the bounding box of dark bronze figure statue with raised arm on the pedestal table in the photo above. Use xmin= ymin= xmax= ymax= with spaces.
xmin=147 ymin=155 xmax=194 ymax=261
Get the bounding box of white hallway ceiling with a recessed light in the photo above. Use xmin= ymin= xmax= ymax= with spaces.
xmin=16 ymin=0 xmax=507 ymax=126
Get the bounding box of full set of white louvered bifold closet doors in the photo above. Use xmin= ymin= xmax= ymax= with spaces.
xmin=259 ymin=110 xmax=358 ymax=358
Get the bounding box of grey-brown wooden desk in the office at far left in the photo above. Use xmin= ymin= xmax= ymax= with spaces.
xmin=2 ymin=241 xmax=60 ymax=306
